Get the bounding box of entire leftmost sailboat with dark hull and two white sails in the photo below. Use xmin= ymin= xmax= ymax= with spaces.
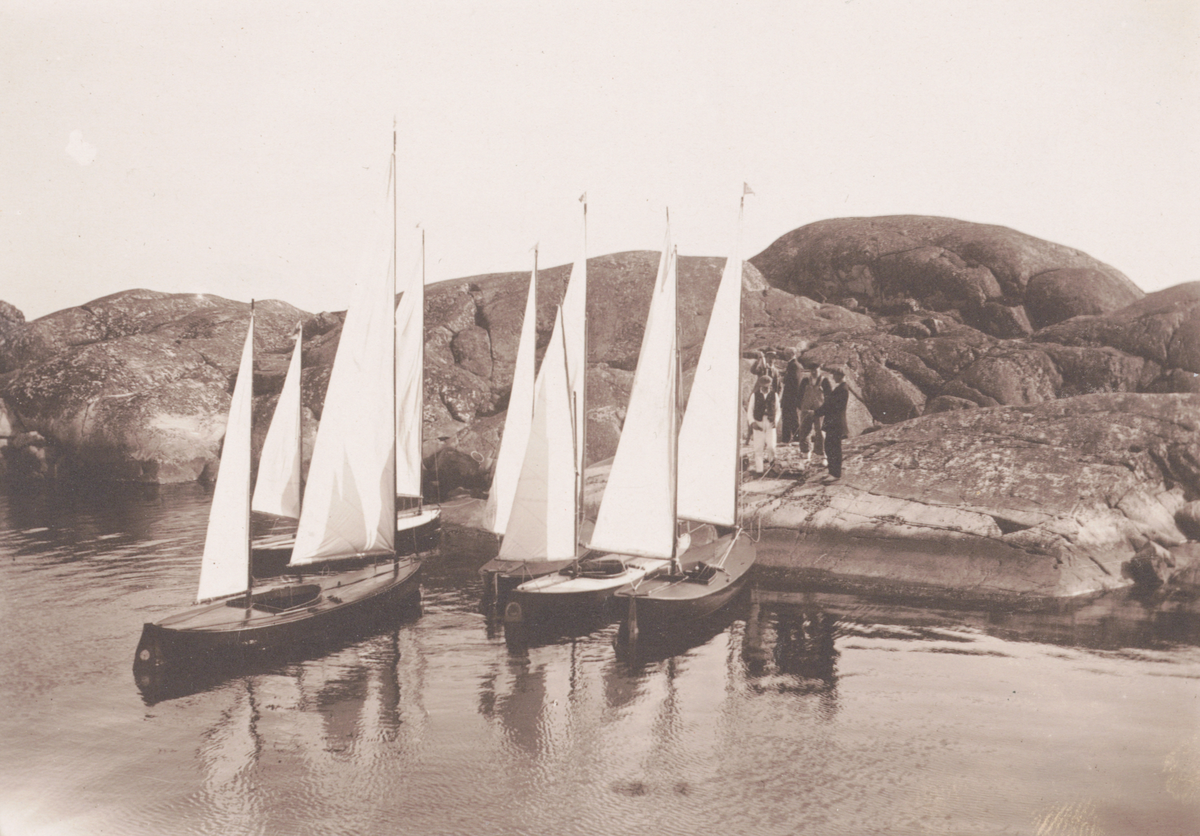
xmin=134 ymin=140 xmax=421 ymax=674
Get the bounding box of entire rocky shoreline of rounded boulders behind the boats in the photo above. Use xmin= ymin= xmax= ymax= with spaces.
xmin=7 ymin=216 xmax=1200 ymax=600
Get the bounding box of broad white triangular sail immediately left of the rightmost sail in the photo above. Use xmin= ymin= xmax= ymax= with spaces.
xmin=590 ymin=225 xmax=678 ymax=558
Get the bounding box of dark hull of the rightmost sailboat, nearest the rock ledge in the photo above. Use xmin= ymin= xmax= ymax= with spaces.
xmin=613 ymin=531 xmax=756 ymax=632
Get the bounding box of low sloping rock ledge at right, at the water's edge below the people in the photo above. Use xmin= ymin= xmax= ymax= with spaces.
xmin=745 ymin=395 xmax=1200 ymax=599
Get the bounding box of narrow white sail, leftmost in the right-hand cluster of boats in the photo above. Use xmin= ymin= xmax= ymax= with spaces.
xmin=487 ymin=261 xmax=538 ymax=534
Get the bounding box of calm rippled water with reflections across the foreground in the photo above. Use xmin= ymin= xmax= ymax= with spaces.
xmin=0 ymin=487 xmax=1200 ymax=836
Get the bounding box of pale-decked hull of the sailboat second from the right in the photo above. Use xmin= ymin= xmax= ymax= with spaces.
xmin=504 ymin=555 xmax=671 ymax=624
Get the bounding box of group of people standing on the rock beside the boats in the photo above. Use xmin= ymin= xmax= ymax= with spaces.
xmin=746 ymin=349 xmax=850 ymax=480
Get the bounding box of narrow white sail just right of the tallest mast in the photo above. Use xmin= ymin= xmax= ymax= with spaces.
xmin=396 ymin=241 xmax=425 ymax=497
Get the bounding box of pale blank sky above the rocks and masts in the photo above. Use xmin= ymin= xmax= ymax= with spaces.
xmin=0 ymin=0 xmax=1200 ymax=319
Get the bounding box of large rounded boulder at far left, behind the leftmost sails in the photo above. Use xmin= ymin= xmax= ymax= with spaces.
xmin=2 ymin=290 xmax=306 ymax=482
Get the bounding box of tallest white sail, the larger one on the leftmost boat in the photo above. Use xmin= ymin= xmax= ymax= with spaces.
xmin=290 ymin=207 xmax=396 ymax=564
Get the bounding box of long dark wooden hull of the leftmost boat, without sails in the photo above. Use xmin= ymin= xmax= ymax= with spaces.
xmin=133 ymin=560 xmax=421 ymax=672
